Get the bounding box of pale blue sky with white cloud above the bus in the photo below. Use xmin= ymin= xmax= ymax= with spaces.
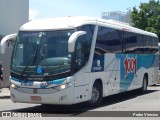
xmin=29 ymin=0 xmax=149 ymax=20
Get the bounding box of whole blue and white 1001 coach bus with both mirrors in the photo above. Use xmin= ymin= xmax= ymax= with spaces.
xmin=1 ymin=17 xmax=159 ymax=106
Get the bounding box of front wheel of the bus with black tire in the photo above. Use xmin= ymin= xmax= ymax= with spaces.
xmin=87 ymin=83 xmax=103 ymax=107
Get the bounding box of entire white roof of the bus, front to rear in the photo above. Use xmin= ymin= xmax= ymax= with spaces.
xmin=20 ymin=16 xmax=157 ymax=37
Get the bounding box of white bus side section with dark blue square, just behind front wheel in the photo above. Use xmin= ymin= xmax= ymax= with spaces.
xmin=90 ymin=53 xmax=120 ymax=96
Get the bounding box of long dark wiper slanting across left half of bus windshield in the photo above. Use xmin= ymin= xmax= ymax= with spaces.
xmin=21 ymin=46 xmax=39 ymax=77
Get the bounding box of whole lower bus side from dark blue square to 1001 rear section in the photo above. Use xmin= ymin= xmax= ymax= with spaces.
xmin=90 ymin=53 xmax=158 ymax=96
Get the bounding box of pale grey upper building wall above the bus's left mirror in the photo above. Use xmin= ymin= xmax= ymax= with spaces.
xmin=0 ymin=0 xmax=29 ymax=35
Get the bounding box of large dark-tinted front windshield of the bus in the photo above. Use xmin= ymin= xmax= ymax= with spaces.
xmin=11 ymin=30 xmax=75 ymax=76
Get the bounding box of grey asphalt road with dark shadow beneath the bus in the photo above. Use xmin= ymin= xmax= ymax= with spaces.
xmin=0 ymin=85 xmax=160 ymax=120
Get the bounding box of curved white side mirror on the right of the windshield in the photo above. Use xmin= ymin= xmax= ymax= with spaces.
xmin=68 ymin=31 xmax=86 ymax=53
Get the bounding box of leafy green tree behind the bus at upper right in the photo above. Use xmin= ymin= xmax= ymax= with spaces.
xmin=130 ymin=0 xmax=160 ymax=40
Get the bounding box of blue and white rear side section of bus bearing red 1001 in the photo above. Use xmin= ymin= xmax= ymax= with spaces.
xmin=116 ymin=54 xmax=158 ymax=92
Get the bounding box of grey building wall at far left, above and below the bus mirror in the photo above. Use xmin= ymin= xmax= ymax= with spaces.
xmin=0 ymin=0 xmax=29 ymax=87
